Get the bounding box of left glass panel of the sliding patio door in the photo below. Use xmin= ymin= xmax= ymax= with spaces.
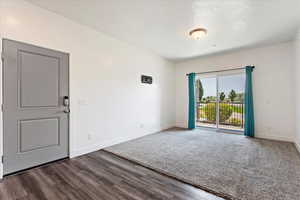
xmin=195 ymin=77 xmax=217 ymax=128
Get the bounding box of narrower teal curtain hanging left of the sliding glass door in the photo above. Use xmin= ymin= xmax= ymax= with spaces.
xmin=188 ymin=73 xmax=196 ymax=129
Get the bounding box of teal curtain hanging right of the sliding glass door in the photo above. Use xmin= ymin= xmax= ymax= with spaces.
xmin=245 ymin=66 xmax=255 ymax=137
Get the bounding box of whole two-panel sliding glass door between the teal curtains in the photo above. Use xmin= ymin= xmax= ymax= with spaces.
xmin=195 ymin=72 xmax=245 ymax=131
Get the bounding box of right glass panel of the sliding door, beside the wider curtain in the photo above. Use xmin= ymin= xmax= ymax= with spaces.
xmin=219 ymin=74 xmax=245 ymax=131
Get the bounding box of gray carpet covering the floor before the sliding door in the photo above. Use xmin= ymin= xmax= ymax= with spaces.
xmin=105 ymin=129 xmax=300 ymax=200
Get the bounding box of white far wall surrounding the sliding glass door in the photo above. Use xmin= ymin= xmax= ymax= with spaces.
xmin=176 ymin=42 xmax=295 ymax=141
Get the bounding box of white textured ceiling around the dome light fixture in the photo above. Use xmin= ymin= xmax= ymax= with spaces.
xmin=27 ymin=0 xmax=300 ymax=60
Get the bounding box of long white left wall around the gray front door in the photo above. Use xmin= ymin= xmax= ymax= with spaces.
xmin=0 ymin=0 xmax=175 ymax=174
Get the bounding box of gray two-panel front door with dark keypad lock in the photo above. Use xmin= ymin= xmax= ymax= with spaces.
xmin=2 ymin=39 xmax=69 ymax=174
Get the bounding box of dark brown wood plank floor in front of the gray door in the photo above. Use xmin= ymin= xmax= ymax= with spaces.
xmin=0 ymin=151 xmax=221 ymax=200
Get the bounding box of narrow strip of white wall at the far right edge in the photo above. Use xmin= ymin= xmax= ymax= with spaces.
xmin=294 ymin=29 xmax=300 ymax=151
